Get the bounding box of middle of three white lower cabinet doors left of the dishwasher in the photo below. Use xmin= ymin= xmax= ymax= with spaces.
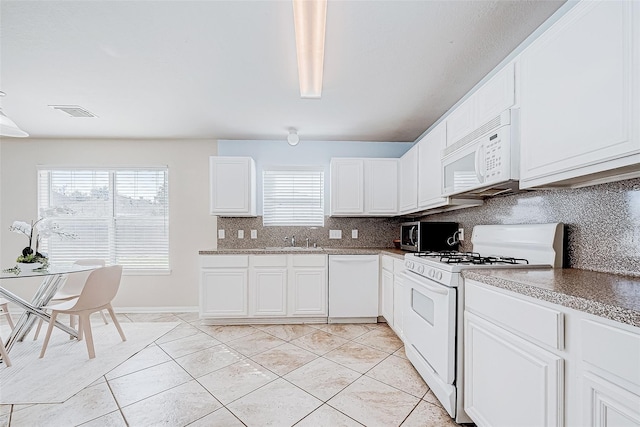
xmin=249 ymin=268 xmax=287 ymax=316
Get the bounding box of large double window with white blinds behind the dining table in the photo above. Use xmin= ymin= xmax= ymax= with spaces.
xmin=38 ymin=167 xmax=169 ymax=273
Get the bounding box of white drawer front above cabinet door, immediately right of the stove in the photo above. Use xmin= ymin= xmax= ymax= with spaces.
xmin=465 ymin=280 xmax=564 ymax=350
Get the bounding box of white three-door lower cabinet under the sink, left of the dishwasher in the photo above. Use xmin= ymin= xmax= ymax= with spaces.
xmin=200 ymin=254 xmax=328 ymax=324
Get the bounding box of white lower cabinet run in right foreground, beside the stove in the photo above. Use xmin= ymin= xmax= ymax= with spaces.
xmin=464 ymin=279 xmax=640 ymax=427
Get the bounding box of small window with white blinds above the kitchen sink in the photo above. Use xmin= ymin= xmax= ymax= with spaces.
xmin=262 ymin=168 xmax=324 ymax=227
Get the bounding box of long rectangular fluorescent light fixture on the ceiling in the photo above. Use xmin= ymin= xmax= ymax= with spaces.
xmin=293 ymin=0 xmax=327 ymax=98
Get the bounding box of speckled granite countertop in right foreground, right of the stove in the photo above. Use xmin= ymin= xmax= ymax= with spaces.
xmin=462 ymin=268 xmax=640 ymax=327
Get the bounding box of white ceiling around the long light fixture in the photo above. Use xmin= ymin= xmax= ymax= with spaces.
xmin=0 ymin=0 xmax=563 ymax=141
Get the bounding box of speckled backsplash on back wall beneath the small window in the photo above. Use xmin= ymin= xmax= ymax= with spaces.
xmin=218 ymin=216 xmax=404 ymax=249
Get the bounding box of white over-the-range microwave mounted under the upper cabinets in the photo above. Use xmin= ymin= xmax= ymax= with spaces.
xmin=442 ymin=109 xmax=520 ymax=197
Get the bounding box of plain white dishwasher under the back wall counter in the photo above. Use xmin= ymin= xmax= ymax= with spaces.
xmin=329 ymin=255 xmax=380 ymax=323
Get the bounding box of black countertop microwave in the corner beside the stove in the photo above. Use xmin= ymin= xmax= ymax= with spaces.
xmin=400 ymin=221 xmax=459 ymax=252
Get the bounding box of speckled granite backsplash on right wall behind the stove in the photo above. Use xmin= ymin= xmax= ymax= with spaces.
xmin=421 ymin=178 xmax=640 ymax=276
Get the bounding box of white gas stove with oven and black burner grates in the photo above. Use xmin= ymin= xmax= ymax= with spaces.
xmin=403 ymin=223 xmax=564 ymax=423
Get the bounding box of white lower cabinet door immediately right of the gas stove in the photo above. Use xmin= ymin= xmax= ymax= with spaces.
xmin=464 ymin=312 xmax=564 ymax=427
